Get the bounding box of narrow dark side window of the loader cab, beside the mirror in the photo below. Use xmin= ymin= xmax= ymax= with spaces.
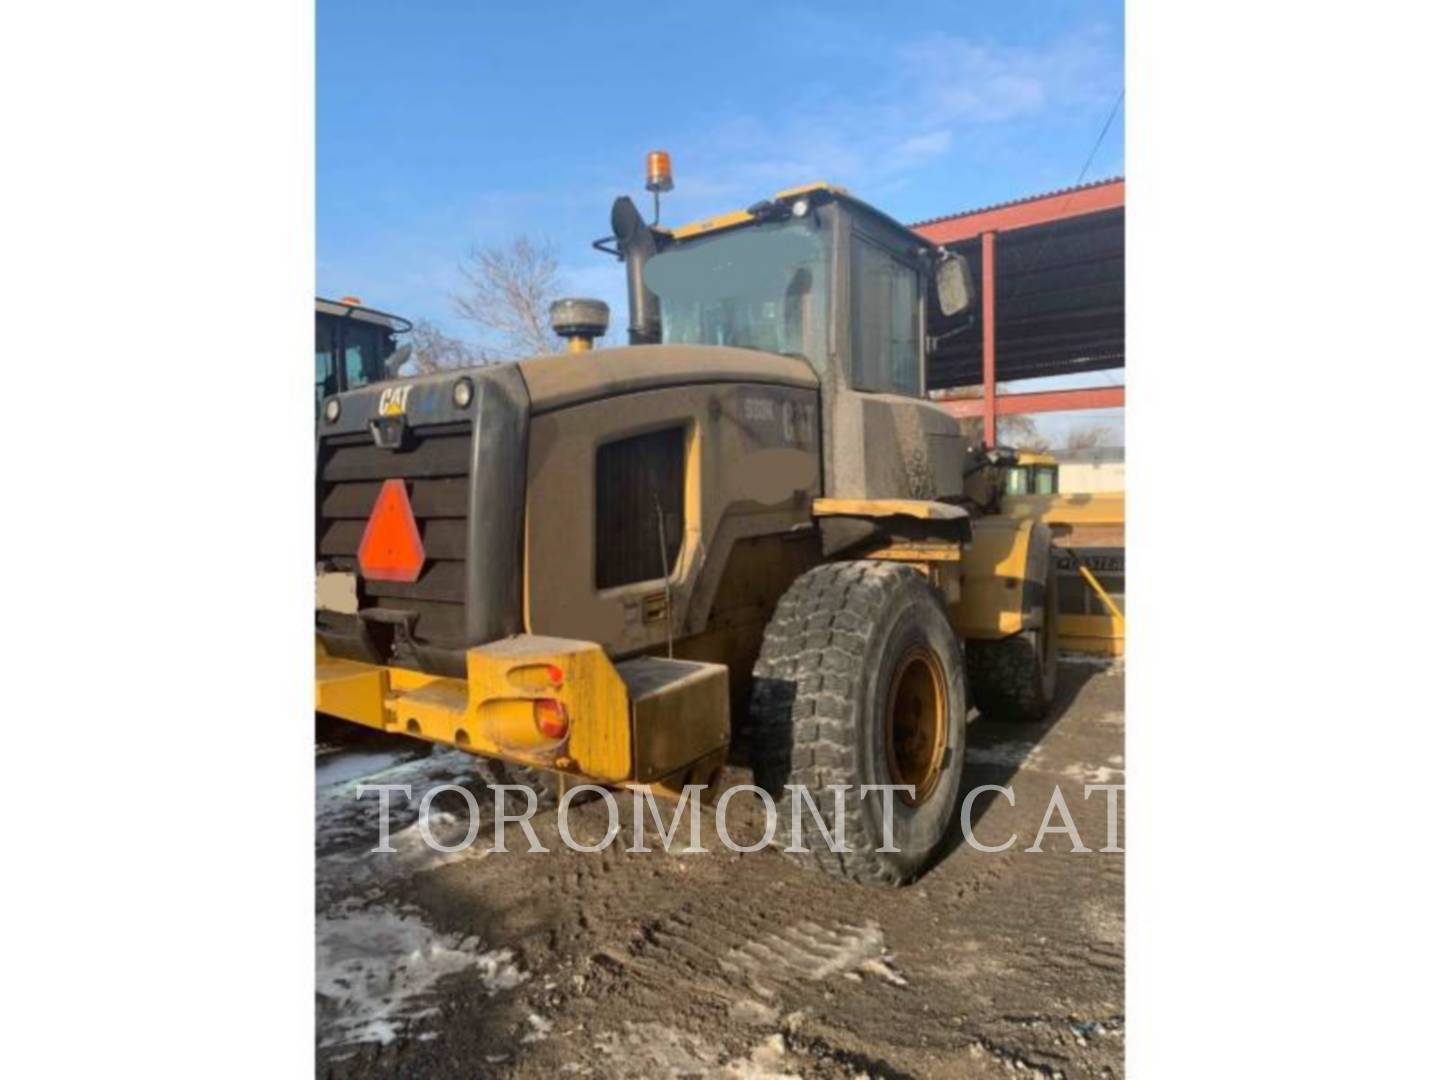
xmin=850 ymin=236 xmax=920 ymax=397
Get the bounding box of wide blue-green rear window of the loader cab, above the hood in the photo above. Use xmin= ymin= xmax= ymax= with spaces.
xmin=645 ymin=217 xmax=831 ymax=372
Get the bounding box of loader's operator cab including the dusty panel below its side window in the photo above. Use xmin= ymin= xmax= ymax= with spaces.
xmin=607 ymin=184 xmax=975 ymax=498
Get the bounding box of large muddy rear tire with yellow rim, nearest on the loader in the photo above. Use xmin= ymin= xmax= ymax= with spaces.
xmin=749 ymin=562 xmax=966 ymax=886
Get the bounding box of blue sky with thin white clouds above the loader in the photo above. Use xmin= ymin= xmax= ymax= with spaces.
xmin=315 ymin=0 xmax=1125 ymax=351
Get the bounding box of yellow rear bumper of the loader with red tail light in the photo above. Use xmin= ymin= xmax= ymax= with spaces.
xmin=315 ymin=635 xmax=730 ymax=783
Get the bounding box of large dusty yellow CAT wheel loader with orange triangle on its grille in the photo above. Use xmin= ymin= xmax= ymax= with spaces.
xmin=315 ymin=162 xmax=1056 ymax=884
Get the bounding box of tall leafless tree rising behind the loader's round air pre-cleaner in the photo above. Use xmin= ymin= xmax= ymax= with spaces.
xmin=451 ymin=236 xmax=560 ymax=359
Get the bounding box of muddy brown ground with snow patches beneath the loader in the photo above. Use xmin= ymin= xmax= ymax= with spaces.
xmin=317 ymin=662 xmax=1125 ymax=1077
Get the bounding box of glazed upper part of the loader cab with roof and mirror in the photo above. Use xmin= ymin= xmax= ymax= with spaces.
xmin=613 ymin=184 xmax=973 ymax=397
